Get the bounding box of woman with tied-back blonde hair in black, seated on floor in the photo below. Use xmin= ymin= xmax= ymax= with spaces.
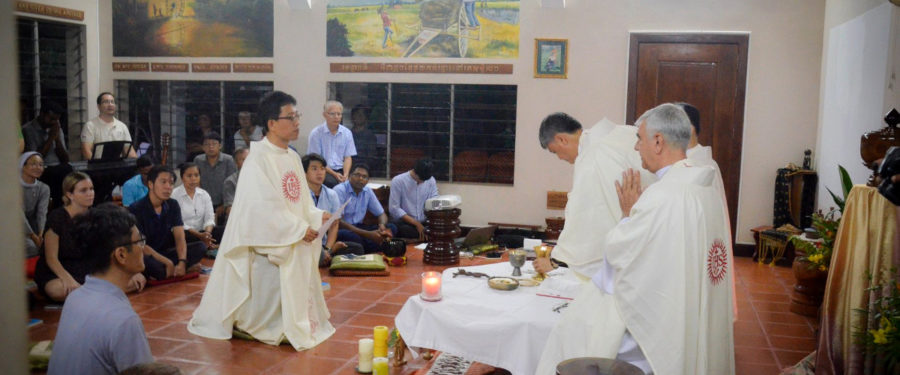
xmin=34 ymin=172 xmax=146 ymax=302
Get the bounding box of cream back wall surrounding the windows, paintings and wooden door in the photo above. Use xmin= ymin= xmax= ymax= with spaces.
xmin=93 ymin=0 xmax=825 ymax=243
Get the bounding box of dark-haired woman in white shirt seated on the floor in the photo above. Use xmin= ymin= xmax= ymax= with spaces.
xmin=172 ymin=162 xmax=218 ymax=258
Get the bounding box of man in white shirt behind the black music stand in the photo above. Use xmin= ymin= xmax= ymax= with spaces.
xmin=81 ymin=92 xmax=137 ymax=160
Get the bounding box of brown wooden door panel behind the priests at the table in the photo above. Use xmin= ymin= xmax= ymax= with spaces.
xmin=626 ymin=33 xmax=749 ymax=241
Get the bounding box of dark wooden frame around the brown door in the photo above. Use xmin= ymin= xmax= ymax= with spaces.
xmin=625 ymin=32 xmax=750 ymax=250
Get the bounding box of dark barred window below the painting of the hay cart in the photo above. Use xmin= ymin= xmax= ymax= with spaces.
xmin=328 ymin=82 xmax=517 ymax=184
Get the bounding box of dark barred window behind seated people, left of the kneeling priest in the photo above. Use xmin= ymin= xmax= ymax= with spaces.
xmin=116 ymin=80 xmax=273 ymax=166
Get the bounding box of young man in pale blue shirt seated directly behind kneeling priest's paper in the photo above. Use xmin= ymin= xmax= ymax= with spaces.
xmin=301 ymin=154 xmax=365 ymax=267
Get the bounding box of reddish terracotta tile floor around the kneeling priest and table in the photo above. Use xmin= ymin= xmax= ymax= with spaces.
xmin=29 ymin=248 xmax=816 ymax=375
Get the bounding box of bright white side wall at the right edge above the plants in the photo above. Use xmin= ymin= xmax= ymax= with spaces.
xmin=816 ymin=0 xmax=900 ymax=208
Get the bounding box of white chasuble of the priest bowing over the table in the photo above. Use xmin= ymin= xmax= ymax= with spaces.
xmin=552 ymin=119 xmax=656 ymax=281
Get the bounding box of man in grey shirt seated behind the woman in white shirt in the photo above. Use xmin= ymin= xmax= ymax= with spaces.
xmin=194 ymin=131 xmax=237 ymax=222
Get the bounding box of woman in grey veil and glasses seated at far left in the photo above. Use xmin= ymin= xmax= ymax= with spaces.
xmin=19 ymin=151 xmax=50 ymax=258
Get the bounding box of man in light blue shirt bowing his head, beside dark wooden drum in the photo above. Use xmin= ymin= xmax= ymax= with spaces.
xmin=388 ymin=158 xmax=438 ymax=241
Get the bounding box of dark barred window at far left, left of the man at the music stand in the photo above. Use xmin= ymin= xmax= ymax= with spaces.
xmin=16 ymin=17 xmax=89 ymax=151
